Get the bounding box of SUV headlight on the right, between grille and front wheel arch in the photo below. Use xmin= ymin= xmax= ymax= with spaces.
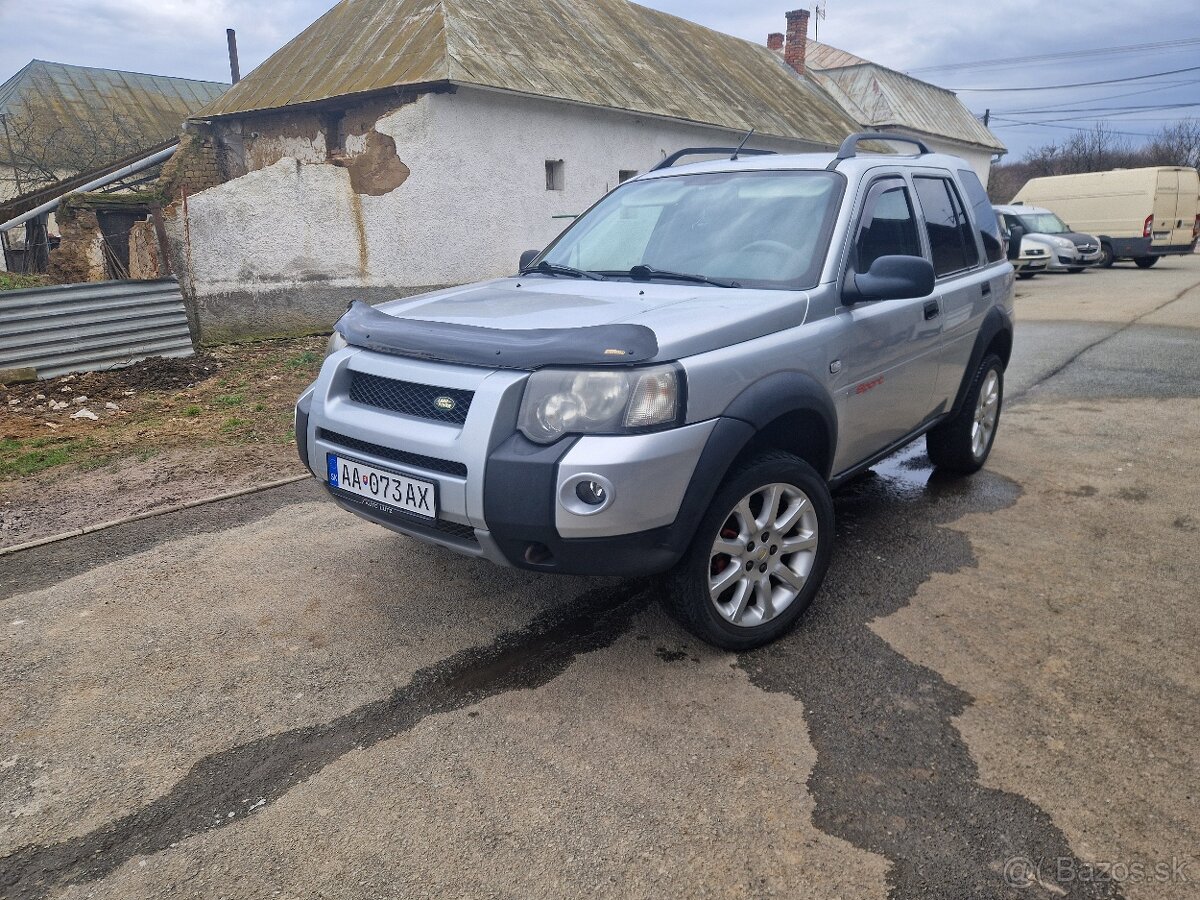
xmin=517 ymin=366 xmax=683 ymax=444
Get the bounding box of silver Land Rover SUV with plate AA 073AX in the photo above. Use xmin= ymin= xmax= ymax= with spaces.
xmin=296 ymin=133 xmax=1013 ymax=649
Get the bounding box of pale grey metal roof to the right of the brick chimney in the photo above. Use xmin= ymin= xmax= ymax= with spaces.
xmin=814 ymin=62 xmax=1007 ymax=152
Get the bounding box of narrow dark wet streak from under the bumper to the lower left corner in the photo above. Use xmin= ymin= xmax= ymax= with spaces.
xmin=0 ymin=581 xmax=650 ymax=900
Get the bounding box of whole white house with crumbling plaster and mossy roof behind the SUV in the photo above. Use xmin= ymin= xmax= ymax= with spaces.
xmin=168 ymin=0 xmax=858 ymax=342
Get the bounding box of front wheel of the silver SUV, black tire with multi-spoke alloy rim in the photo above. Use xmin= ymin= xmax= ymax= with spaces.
xmin=664 ymin=451 xmax=833 ymax=650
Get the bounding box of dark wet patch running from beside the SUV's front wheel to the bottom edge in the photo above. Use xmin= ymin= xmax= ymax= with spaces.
xmin=739 ymin=451 xmax=1120 ymax=900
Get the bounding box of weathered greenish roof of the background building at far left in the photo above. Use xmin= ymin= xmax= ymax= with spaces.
xmin=0 ymin=59 xmax=229 ymax=168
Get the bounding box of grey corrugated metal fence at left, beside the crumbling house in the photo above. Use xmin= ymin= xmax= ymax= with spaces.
xmin=0 ymin=278 xmax=192 ymax=378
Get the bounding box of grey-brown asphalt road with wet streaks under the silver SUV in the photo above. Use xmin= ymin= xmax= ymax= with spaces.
xmin=0 ymin=257 xmax=1200 ymax=900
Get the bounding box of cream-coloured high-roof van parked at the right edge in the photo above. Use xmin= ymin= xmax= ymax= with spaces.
xmin=1013 ymin=166 xmax=1200 ymax=269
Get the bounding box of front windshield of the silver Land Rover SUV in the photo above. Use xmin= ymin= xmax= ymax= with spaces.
xmin=539 ymin=172 xmax=841 ymax=290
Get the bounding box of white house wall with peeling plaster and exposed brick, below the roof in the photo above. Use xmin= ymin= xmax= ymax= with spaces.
xmin=168 ymin=89 xmax=830 ymax=343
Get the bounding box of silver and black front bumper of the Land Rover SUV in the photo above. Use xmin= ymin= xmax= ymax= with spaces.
xmin=296 ymin=348 xmax=716 ymax=575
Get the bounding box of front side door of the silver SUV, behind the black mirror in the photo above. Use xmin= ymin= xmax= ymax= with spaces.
xmin=834 ymin=175 xmax=942 ymax=473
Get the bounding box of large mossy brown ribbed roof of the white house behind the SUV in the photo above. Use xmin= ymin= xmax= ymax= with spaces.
xmin=199 ymin=0 xmax=858 ymax=145
